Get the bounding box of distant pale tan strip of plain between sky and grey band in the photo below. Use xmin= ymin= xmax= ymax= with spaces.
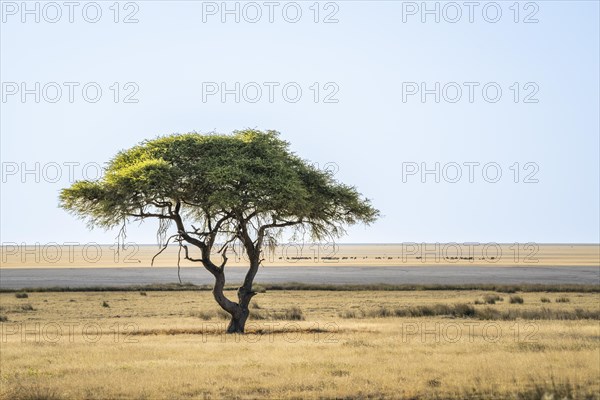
xmin=0 ymin=243 xmax=600 ymax=268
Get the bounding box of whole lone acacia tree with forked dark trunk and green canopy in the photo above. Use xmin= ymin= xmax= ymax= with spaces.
xmin=60 ymin=130 xmax=379 ymax=333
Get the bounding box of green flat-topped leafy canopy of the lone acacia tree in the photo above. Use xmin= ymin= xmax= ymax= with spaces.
xmin=60 ymin=130 xmax=379 ymax=244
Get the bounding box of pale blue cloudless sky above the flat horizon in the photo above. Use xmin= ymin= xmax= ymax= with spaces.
xmin=0 ymin=1 xmax=600 ymax=243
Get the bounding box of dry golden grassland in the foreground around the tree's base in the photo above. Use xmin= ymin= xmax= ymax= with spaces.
xmin=0 ymin=288 xmax=600 ymax=400
